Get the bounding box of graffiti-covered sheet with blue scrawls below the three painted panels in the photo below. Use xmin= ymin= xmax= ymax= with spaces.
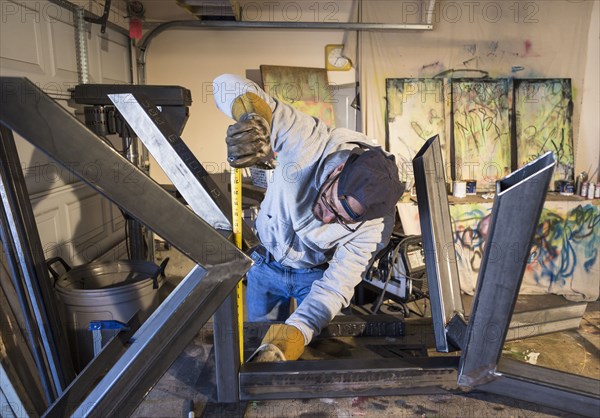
xmin=450 ymin=201 xmax=600 ymax=301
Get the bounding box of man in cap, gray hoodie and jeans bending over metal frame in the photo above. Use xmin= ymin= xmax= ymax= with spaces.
xmin=213 ymin=74 xmax=404 ymax=361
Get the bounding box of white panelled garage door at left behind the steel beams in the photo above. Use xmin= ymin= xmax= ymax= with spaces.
xmin=0 ymin=0 xmax=131 ymax=265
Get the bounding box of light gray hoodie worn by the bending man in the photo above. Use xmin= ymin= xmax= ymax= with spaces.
xmin=213 ymin=74 xmax=395 ymax=344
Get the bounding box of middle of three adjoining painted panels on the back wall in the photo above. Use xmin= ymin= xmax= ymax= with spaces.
xmin=451 ymin=79 xmax=512 ymax=192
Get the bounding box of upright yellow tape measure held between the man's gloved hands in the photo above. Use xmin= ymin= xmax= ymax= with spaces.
xmin=231 ymin=168 xmax=244 ymax=363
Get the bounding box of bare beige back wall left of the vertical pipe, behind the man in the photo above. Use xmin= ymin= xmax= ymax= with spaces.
xmin=147 ymin=29 xmax=355 ymax=183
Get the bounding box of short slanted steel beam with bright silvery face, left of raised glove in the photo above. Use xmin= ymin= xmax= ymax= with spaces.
xmin=109 ymin=92 xmax=258 ymax=248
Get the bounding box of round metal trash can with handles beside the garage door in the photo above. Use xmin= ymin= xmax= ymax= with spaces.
xmin=47 ymin=257 xmax=169 ymax=371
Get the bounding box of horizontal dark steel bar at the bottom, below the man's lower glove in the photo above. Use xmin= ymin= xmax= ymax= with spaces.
xmin=240 ymin=357 xmax=458 ymax=401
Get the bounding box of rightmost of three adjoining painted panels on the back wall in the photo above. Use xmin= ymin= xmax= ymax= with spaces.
xmin=514 ymin=79 xmax=575 ymax=184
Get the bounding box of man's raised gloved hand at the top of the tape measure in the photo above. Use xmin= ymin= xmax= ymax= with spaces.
xmin=226 ymin=112 xmax=272 ymax=168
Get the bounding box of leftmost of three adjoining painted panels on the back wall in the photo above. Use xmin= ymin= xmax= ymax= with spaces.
xmin=386 ymin=78 xmax=449 ymax=184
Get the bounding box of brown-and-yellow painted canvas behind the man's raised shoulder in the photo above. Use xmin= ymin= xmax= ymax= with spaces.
xmin=260 ymin=65 xmax=335 ymax=127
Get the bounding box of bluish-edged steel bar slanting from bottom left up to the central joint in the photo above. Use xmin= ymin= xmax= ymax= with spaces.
xmin=73 ymin=260 xmax=250 ymax=417
